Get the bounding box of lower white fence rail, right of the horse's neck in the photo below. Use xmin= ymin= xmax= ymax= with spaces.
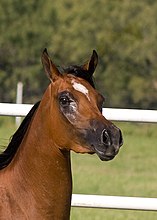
xmin=72 ymin=194 xmax=157 ymax=211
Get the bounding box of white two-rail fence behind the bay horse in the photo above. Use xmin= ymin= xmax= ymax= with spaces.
xmin=0 ymin=103 xmax=157 ymax=211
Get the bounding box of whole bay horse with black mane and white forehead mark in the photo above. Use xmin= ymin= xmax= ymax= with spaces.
xmin=0 ymin=49 xmax=123 ymax=220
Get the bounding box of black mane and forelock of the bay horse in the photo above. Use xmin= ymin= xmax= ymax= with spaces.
xmin=0 ymin=66 xmax=95 ymax=170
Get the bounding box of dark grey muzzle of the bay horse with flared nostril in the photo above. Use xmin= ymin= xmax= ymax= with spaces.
xmin=85 ymin=120 xmax=123 ymax=161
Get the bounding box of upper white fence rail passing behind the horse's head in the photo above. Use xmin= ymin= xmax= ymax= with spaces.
xmin=0 ymin=103 xmax=157 ymax=123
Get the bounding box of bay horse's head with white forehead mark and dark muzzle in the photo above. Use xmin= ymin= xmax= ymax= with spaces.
xmin=41 ymin=49 xmax=123 ymax=161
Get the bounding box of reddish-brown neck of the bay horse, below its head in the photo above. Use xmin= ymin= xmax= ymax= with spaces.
xmin=5 ymin=98 xmax=72 ymax=219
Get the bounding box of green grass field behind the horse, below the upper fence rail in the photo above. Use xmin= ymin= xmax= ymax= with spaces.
xmin=0 ymin=117 xmax=157 ymax=220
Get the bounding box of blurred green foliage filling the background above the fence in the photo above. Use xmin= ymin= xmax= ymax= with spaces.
xmin=0 ymin=0 xmax=157 ymax=108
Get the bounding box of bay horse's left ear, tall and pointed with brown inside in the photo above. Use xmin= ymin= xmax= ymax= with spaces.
xmin=41 ymin=48 xmax=61 ymax=81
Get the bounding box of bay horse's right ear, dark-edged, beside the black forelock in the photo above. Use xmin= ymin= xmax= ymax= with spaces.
xmin=83 ymin=50 xmax=98 ymax=75
